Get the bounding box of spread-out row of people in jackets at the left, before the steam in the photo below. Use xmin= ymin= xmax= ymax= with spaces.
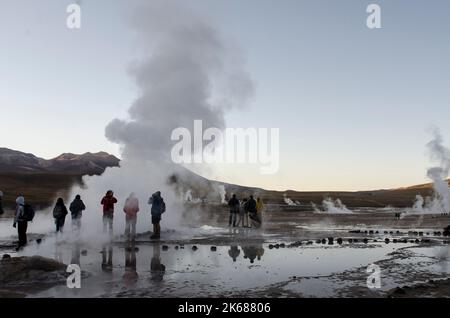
xmin=8 ymin=190 xmax=166 ymax=249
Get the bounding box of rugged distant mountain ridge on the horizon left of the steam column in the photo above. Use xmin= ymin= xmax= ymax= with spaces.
xmin=0 ymin=148 xmax=120 ymax=175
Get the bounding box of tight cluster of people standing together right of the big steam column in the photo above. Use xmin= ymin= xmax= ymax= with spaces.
xmin=228 ymin=194 xmax=264 ymax=228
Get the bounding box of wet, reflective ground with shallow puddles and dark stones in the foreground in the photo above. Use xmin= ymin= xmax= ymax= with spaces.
xmin=0 ymin=210 xmax=450 ymax=297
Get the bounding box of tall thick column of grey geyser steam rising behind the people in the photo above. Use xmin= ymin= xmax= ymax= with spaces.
xmin=68 ymin=0 xmax=253 ymax=232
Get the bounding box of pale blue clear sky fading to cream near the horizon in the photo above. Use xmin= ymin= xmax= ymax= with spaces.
xmin=0 ymin=0 xmax=450 ymax=191
